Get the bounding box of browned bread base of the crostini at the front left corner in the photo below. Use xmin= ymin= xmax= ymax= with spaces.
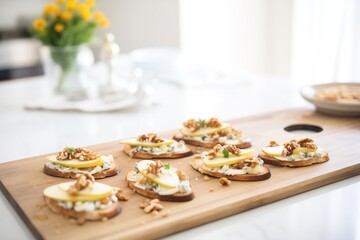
xmin=44 ymin=197 xmax=121 ymax=221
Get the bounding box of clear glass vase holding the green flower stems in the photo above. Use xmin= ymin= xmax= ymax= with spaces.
xmin=42 ymin=45 xmax=94 ymax=100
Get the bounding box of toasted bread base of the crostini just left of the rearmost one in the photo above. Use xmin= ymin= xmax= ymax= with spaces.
xmin=124 ymin=145 xmax=193 ymax=159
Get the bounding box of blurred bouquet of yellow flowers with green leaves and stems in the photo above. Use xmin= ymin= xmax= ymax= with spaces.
xmin=31 ymin=0 xmax=109 ymax=93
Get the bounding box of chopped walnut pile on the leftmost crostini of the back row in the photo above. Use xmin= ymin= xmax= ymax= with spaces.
xmin=56 ymin=147 xmax=100 ymax=161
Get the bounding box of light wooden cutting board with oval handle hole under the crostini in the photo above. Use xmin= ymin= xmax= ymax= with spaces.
xmin=0 ymin=109 xmax=360 ymax=239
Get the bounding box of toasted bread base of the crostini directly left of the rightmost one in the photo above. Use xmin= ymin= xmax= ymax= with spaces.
xmin=190 ymin=159 xmax=271 ymax=181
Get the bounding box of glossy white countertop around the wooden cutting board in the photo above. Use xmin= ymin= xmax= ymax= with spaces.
xmin=0 ymin=77 xmax=360 ymax=240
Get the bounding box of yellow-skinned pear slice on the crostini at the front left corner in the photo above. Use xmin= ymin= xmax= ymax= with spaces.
xmin=43 ymin=182 xmax=112 ymax=202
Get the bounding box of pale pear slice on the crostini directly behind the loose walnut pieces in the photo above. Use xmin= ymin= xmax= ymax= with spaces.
xmin=137 ymin=160 xmax=180 ymax=188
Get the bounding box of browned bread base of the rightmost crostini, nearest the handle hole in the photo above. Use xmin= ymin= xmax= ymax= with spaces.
xmin=259 ymin=152 xmax=329 ymax=167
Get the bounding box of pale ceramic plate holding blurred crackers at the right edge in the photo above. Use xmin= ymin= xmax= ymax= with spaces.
xmin=300 ymin=83 xmax=360 ymax=117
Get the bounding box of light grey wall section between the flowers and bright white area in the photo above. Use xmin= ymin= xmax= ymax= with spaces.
xmin=98 ymin=0 xmax=179 ymax=52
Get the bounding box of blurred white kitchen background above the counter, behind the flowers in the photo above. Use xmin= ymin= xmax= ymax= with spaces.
xmin=0 ymin=0 xmax=360 ymax=83
